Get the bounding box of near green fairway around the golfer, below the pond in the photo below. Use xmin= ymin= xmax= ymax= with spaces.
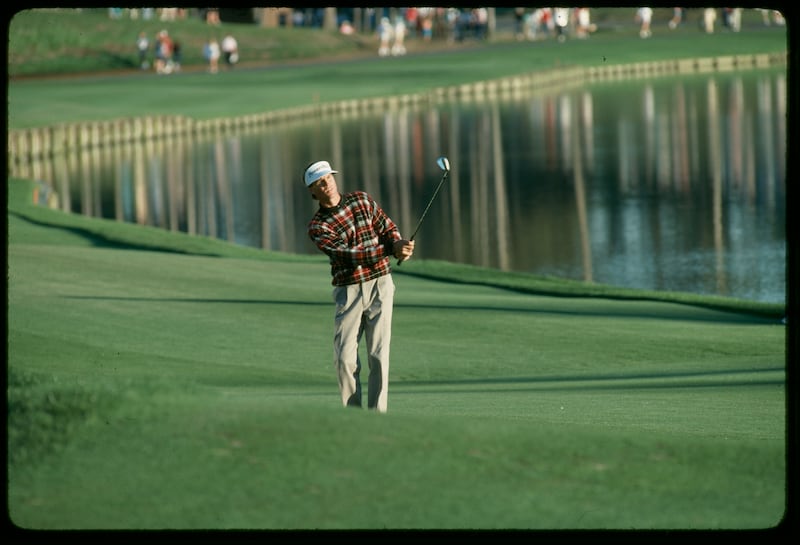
xmin=8 ymin=177 xmax=786 ymax=529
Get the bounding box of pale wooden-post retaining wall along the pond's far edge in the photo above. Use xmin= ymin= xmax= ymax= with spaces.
xmin=7 ymin=52 xmax=788 ymax=168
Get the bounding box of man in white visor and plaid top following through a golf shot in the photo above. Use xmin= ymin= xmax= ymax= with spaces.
xmin=303 ymin=161 xmax=414 ymax=413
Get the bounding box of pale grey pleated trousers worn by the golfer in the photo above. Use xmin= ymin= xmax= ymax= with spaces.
xmin=333 ymin=274 xmax=395 ymax=413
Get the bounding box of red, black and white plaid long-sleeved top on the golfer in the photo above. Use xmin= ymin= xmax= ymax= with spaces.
xmin=308 ymin=191 xmax=401 ymax=286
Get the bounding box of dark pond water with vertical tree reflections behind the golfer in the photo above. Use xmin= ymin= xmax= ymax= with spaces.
xmin=17 ymin=71 xmax=787 ymax=302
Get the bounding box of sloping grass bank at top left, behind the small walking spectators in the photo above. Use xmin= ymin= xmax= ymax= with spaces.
xmin=4 ymin=8 xmax=374 ymax=77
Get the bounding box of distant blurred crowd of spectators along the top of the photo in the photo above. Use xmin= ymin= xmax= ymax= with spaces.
xmin=109 ymin=7 xmax=785 ymax=70
